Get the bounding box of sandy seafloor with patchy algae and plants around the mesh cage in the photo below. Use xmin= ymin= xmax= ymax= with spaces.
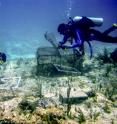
xmin=0 ymin=47 xmax=117 ymax=124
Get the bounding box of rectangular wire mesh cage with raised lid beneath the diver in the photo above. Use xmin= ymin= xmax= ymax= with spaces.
xmin=36 ymin=32 xmax=84 ymax=76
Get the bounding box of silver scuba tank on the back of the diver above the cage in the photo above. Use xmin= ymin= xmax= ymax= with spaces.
xmin=73 ymin=16 xmax=103 ymax=26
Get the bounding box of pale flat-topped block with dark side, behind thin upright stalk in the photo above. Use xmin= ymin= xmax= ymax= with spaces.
xmin=59 ymin=88 xmax=88 ymax=104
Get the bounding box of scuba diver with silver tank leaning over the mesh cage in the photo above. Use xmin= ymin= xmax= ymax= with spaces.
xmin=58 ymin=16 xmax=117 ymax=58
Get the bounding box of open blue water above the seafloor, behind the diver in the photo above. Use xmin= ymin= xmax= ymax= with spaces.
xmin=0 ymin=0 xmax=117 ymax=59
